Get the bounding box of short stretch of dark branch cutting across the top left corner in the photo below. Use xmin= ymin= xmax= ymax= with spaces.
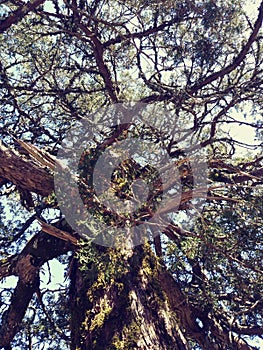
xmin=0 ymin=0 xmax=45 ymax=33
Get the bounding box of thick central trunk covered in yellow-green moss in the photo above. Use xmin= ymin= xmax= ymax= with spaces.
xmin=71 ymin=246 xmax=191 ymax=350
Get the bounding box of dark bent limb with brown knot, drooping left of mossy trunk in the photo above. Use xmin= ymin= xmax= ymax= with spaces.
xmin=0 ymin=223 xmax=75 ymax=348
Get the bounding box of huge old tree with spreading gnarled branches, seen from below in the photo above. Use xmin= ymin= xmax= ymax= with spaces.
xmin=0 ymin=0 xmax=263 ymax=350
